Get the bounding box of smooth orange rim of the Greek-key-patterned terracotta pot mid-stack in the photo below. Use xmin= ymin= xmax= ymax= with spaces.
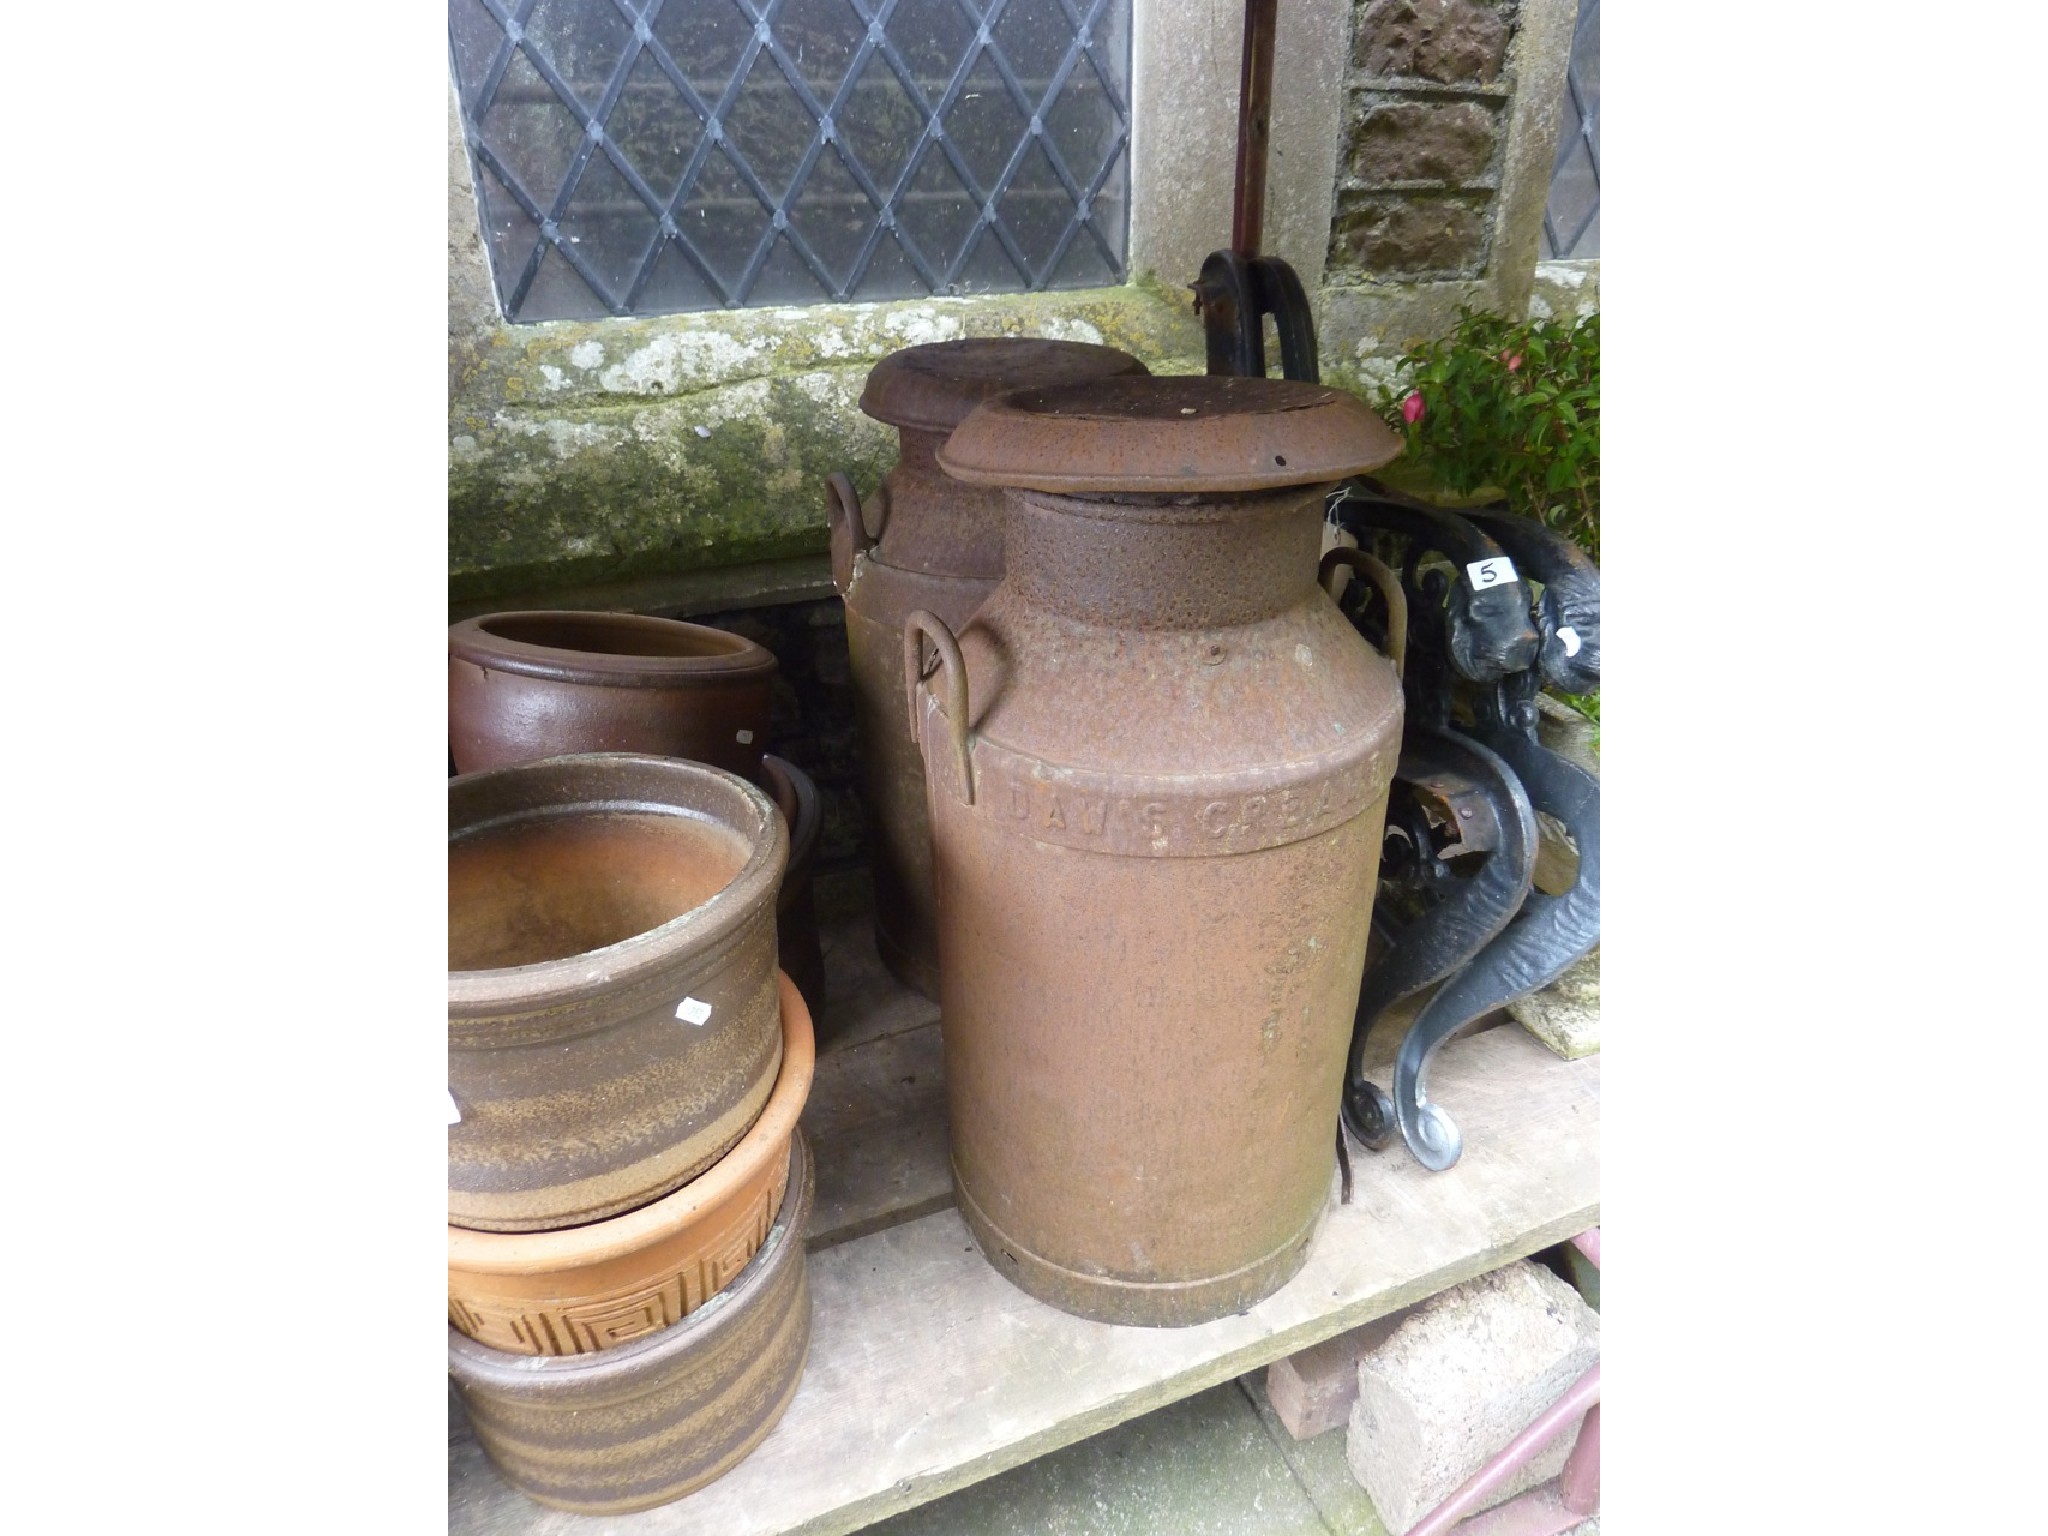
xmin=449 ymin=971 xmax=817 ymax=1277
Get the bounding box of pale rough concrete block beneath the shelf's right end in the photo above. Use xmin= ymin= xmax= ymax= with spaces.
xmin=1346 ymin=1260 xmax=1599 ymax=1536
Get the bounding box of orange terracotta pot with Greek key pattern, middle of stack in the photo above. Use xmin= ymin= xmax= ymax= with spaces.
xmin=449 ymin=975 xmax=813 ymax=1354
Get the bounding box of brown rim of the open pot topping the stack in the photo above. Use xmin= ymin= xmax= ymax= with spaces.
xmin=449 ymin=752 xmax=788 ymax=1020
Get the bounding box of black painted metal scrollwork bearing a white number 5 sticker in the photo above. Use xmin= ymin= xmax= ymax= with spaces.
xmin=1331 ymin=493 xmax=1599 ymax=1171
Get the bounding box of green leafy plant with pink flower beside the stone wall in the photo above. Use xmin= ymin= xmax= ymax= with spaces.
xmin=1382 ymin=309 xmax=1599 ymax=563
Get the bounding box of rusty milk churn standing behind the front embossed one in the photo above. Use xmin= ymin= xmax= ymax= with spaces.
xmin=825 ymin=336 xmax=1145 ymax=997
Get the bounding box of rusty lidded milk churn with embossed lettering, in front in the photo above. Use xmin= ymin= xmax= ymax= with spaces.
xmin=901 ymin=377 xmax=1401 ymax=1325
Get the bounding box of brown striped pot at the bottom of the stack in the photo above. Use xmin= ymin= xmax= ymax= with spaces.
xmin=449 ymin=1135 xmax=811 ymax=1516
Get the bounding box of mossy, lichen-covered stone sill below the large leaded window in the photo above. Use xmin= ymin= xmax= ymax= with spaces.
xmin=449 ymin=287 xmax=1202 ymax=602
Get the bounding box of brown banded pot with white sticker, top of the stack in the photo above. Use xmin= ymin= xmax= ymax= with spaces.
xmin=449 ymin=754 xmax=788 ymax=1231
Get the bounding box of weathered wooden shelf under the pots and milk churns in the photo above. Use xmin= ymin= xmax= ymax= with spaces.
xmin=449 ymin=901 xmax=1599 ymax=1536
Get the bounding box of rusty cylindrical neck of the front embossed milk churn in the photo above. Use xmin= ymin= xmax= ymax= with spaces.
xmin=1004 ymin=485 xmax=1329 ymax=629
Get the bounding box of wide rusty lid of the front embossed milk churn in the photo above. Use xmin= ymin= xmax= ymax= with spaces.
xmin=938 ymin=375 xmax=1401 ymax=496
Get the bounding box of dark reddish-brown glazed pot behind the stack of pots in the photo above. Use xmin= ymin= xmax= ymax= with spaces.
xmin=449 ymin=610 xmax=776 ymax=778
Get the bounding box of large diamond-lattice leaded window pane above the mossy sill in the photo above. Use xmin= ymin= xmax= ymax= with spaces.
xmin=449 ymin=0 xmax=1130 ymax=319
